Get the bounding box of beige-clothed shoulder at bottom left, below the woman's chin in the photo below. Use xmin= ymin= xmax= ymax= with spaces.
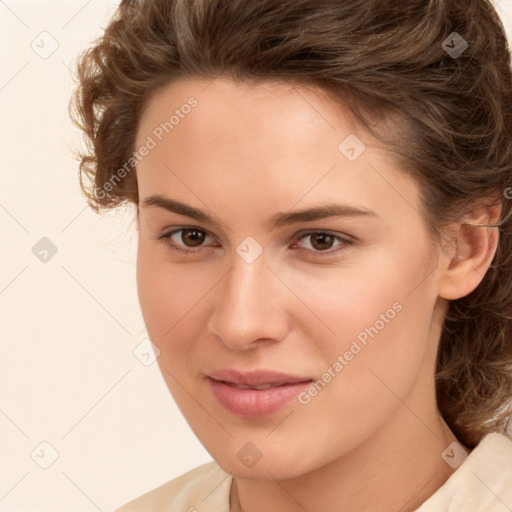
xmin=115 ymin=461 xmax=232 ymax=512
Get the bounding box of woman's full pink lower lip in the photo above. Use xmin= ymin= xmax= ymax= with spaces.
xmin=207 ymin=377 xmax=312 ymax=418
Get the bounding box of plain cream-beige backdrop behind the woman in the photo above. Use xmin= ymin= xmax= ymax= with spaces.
xmin=0 ymin=0 xmax=512 ymax=512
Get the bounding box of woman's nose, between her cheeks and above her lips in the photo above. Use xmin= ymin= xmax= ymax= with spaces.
xmin=207 ymin=251 xmax=290 ymax=350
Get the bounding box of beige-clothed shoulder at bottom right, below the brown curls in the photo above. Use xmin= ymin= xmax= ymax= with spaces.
xmin=415 ymin=432 xmax=512 ymax=512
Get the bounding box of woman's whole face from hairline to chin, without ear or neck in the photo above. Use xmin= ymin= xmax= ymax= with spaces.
xmin=136 ymin=79 xmax=443 ymax=479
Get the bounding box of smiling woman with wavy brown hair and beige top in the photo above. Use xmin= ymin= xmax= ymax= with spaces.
xmin=74 ymin=0 xmax=512 ymax=512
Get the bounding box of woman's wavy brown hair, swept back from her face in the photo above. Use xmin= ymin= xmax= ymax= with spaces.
xmin=70 ymin=0 xmax=512 ymax=447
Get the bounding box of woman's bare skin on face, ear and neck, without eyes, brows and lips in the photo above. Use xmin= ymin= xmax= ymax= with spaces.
xmin=132 ymin=78 xmax=499 ymax=512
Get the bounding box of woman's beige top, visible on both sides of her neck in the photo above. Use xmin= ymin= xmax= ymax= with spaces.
xmin=115 ymin=432 xmax=512 ymax=512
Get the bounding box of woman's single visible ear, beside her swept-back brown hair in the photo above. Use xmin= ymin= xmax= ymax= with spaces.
xmin=438 ymin=203 xmax=501 ymax=300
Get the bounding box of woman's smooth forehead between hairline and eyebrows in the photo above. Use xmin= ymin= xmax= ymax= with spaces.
xmin=137 ymin=78 xmax=417 ymax=226
